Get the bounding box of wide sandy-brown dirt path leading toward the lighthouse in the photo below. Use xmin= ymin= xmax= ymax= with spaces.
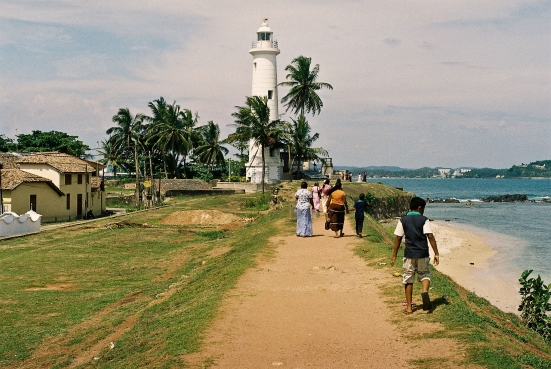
xmin=185 ymin=214 xmax=472 ymax=369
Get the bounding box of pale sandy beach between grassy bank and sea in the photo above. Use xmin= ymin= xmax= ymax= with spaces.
xmin=431 ymin=221 xmax=520 ymax=314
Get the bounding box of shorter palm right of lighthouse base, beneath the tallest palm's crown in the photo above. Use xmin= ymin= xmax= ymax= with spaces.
xmin=287 ymin=115 xmax=328 ymax=179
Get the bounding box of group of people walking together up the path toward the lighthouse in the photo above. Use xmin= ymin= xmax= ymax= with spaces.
xmin=295 ymin=179 xmax=368 ymax=238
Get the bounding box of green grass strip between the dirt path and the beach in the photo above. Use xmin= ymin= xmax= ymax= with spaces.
xmin=351 ymin=211 xmax=551 ymax=369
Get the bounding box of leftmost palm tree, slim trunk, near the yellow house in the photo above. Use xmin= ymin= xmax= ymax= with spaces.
xmin=106 ymin=108 xmax=145 ymax=207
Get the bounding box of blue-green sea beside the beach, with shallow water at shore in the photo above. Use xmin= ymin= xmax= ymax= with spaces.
xmin=368 ymin=178 xmax=551 ymax=285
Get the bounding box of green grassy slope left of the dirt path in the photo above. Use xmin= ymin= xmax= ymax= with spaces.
xmin=0 ymin=195 xmax=281 ymax=368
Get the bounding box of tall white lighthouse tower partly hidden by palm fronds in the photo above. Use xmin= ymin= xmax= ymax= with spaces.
xmin=247 ymin=19 xmax=283 ymax=183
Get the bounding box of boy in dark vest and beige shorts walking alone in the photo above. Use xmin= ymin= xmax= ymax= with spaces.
xmin=390 ymin=197 xmax=440 ymax=314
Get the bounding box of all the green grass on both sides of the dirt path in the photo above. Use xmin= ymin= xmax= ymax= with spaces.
xmin=0 ymin=183 xmax=551 ymax=369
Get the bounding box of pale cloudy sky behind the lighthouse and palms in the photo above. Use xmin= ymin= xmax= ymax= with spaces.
xmin=0 ymin=0 xmax=551 ymax=168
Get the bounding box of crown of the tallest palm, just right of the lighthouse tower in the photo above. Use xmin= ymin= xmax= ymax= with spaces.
xmin=278 ymin=55 xmax=333 ymax=115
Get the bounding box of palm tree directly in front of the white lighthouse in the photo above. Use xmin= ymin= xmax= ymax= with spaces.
xmin=232 ymin=96 xmax=284 ymax=192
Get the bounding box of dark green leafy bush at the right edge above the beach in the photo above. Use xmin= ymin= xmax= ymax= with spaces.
xmin=518 ymin=270 xmax=551 ymax=340
